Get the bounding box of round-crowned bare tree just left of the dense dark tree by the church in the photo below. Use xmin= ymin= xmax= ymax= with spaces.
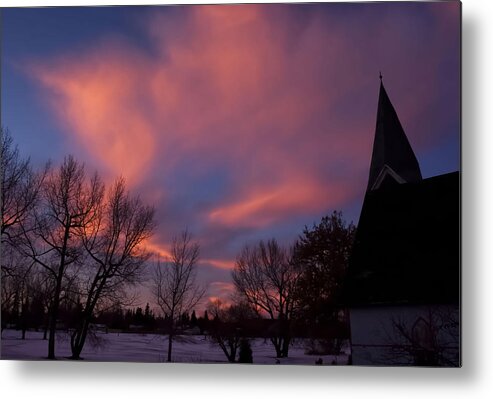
xmin=232 ymin=239 xmax=299 ymax=357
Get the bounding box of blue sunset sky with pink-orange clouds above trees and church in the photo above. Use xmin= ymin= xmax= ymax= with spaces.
xmin=1 ymin=2 xmax=460 ymax=310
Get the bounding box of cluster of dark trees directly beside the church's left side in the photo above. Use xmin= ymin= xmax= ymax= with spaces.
xmin=209 ymin=212 xmax=355 ymax=361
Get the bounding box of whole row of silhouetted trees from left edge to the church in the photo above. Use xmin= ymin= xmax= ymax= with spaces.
xmin=1 ymin=129 xmax=355 ymax=362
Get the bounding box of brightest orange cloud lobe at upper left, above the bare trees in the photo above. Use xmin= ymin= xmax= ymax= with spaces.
xmin=33 ymin=45 xmax=155 ymax=183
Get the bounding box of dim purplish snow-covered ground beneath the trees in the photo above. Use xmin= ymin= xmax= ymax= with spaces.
xmin=1 ymin=330 xmax=347 ymax=365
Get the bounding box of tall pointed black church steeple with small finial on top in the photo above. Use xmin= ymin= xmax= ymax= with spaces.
xmin=367 ymin=78 xmax=422 ymax=191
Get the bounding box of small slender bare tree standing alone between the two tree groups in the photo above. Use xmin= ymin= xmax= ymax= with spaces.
xmin=152 ymin=231 xmax=205 ymax=362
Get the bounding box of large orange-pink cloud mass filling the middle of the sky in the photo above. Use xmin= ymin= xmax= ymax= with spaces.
xmin=29 ymin=5 xmax=366 ymax=231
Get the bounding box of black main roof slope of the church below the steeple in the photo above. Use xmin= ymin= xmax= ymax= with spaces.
xmin=344 ymin=172 xmax=460 ymax=306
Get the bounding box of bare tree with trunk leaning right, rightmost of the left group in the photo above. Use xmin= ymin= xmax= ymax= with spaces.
xmin=71 ymin=179 xmax=154 ymax=359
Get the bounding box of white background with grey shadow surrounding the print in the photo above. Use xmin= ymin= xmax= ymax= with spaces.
xmin=0 ymin=0 xmax=493 ymax=399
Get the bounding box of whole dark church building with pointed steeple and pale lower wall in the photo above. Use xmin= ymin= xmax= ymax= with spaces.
xmin=344 ymin=77 xmax=461 ymax=367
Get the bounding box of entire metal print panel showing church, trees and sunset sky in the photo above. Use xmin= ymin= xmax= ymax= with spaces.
xmin=1 ymin=1 xmax=461 ymax=367
